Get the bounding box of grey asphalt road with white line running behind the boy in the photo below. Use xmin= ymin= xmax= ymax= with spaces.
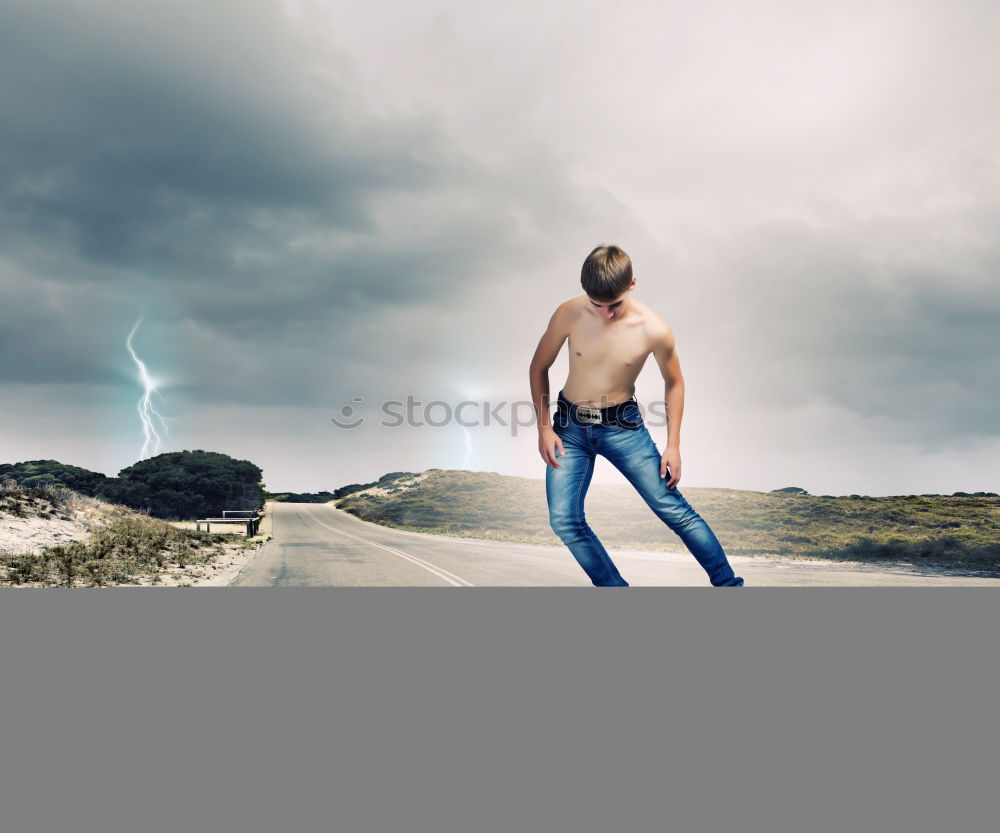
xmin=232 ymin=503 xmax=1000 ymax=590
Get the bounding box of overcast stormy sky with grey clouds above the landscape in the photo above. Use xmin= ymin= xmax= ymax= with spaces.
xmin=0 ymin=0 xmax=1000 ymax=495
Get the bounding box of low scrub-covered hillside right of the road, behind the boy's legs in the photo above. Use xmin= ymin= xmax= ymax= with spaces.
xmin=335 ymin=469 xmax=1000 ymax=575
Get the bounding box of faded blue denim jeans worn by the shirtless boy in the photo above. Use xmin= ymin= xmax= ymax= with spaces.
xmin=545 ymin=391 xmax=743 ymax=587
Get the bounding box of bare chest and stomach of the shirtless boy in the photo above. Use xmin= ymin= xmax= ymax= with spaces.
xmin=563 ymin=295 xmax=662 ymax=408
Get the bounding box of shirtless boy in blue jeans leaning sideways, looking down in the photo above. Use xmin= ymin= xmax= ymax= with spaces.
xmin=531 ymin=246 xmax=743 ymax=587
